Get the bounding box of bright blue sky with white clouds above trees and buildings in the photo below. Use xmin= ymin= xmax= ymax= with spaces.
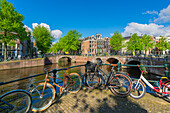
xmin=8 ymin=0 xmax=170 ymax=41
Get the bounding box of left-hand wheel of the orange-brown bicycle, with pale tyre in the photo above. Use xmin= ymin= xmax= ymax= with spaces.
xmin=31 ymin=83 xmax=55 ymax=112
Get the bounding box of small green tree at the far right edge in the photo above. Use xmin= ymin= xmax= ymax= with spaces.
xmin=155 ymin=36 xmax=170 ymax=54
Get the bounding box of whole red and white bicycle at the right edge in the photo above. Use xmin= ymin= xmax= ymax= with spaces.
xmin=130 ymin=65 xmax=170 ymax=100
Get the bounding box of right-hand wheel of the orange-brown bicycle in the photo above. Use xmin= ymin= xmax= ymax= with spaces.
xmin=67 ymin=73 xmax=82 ymax=93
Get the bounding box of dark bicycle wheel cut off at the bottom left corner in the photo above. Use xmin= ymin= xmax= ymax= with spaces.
xmin=0 ymin=90 xmax=32 ymax=113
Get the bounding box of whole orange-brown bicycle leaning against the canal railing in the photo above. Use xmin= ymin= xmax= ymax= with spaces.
xmin=30 ymin=68 xmax=82 ymax=112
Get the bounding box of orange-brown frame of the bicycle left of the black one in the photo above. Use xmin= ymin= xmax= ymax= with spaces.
xmin=41 ymin=70 xmax=75 ymax=97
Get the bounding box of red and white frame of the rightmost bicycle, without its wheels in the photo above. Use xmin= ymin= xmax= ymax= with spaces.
xmin=135 ymin=72 xmax=170 ymax=94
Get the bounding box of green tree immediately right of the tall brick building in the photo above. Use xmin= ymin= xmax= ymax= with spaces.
xmin=110 ymin=31 xmax=124 ymax=54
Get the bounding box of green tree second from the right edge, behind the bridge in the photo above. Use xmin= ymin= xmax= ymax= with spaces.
xmin=141 ymin=34 xmax=154 ymax=55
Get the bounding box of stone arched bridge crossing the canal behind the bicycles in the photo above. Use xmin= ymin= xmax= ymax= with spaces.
xmin=49 ymin=55 xmax=170 ymax=76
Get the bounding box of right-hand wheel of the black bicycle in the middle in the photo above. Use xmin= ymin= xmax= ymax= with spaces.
xmin=109 ymin=74 xmax=132 ymax=97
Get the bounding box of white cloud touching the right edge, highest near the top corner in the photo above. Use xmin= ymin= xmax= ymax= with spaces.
xmin=154 ymin=5 xmax=170 ymax=23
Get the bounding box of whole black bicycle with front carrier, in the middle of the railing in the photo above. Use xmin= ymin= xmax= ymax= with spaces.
xmin=83 ymin=61 xmax=132 ymax=97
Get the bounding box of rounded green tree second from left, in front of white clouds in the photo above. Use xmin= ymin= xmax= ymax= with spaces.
xmin=33 ymin=25 xmax=54 ymax=54
